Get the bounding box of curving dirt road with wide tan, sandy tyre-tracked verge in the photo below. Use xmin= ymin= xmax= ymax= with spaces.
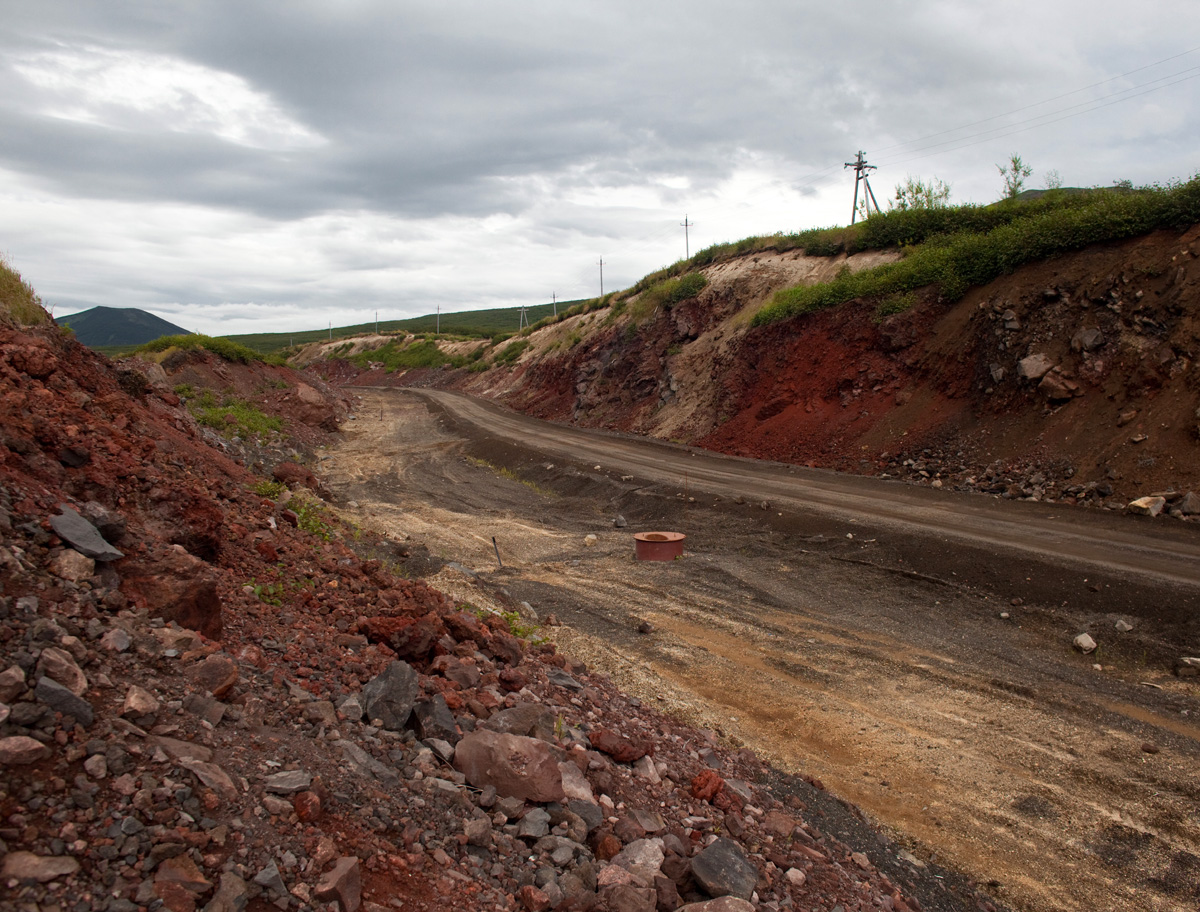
xmin=323 ymin=391 xmax=1200 ymax=910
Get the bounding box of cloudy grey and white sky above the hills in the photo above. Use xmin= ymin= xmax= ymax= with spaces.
xmin=0 ymin=0 xmax=1200 ymax=335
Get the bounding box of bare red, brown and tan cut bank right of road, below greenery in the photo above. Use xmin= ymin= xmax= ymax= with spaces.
xmin=326 ymin=227 xmax=1200 ymax=516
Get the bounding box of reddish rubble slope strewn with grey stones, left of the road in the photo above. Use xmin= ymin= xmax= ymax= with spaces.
xmin=0 ymin=329 xmax=989 ymax=912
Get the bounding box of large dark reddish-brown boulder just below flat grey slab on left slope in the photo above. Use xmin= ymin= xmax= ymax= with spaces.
xmin=120 ymin=547 xmax=222 ymax=640
